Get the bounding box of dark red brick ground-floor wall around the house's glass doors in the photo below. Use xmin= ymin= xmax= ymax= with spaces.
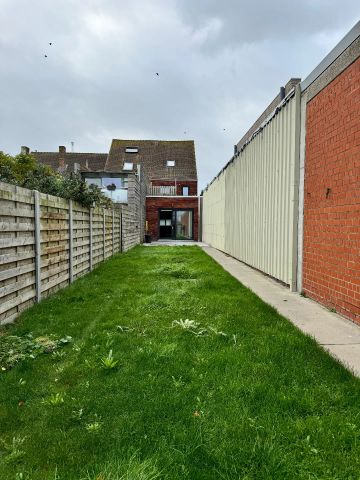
xmin=146 ymin=197 xmax=199 ymax=240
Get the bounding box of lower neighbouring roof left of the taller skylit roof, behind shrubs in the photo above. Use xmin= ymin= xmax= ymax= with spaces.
xmin=31 ymin=152 xmax=108 ymax=173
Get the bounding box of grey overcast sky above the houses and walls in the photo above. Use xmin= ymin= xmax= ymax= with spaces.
xmin=0 ymin=0 xmax=360 ymax=187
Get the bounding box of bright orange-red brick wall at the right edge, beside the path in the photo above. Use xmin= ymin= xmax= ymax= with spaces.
xmin=303 ymin=59 xmax=360 ymax=323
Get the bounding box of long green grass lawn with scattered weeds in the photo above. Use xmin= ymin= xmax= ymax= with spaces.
xmin=0 ymin=247 xmax=360 ymax=480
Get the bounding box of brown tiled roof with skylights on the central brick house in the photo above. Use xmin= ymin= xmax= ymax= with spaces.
xmin=106 ymin=139 xmax=197 ymax=181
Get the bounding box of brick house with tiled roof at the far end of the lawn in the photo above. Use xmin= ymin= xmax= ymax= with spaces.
xmin=107 ymin=140 xmax=198 ymax=240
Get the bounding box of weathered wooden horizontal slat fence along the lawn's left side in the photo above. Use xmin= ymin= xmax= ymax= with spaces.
xmin=0 ymin=182 xmax=140 ymax=325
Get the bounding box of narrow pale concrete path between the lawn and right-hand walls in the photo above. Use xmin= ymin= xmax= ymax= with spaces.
xmin=202 ymin=246 xmax=360 ymax=377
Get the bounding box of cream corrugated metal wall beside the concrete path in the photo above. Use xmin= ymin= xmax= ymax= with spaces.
xmin=202 ymin=88 xmax=300 ymax=290
